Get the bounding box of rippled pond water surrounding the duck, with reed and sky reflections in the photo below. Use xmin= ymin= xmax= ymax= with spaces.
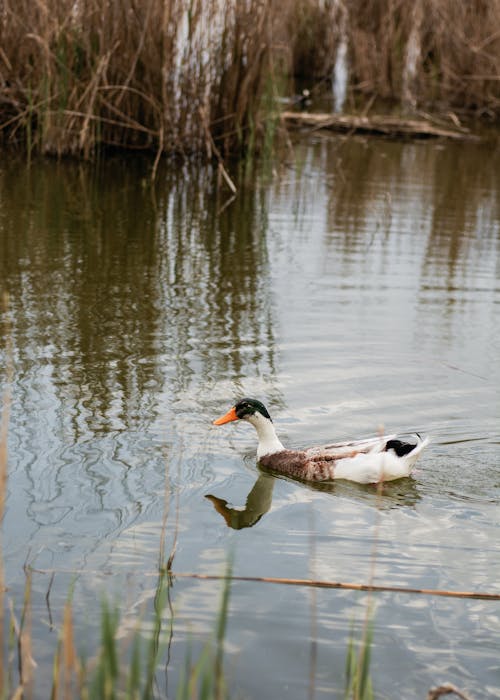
xmin=0 ymin=135 xmax=500 ymax=700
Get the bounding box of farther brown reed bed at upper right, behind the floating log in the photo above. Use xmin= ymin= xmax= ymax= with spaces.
xmin=291 ymin=0 xmax=500 ymax=121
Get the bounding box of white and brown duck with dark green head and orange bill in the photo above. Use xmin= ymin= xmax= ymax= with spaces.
xmin=213 ymin=398 xmax=429 ymax=484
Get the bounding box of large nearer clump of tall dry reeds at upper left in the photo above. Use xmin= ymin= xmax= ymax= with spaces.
xmin=0 ymin=0 xmax=286 ymax=157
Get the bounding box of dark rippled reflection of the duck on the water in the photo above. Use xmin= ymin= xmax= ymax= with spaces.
xmin=205 ymin=472 xmax=421 ymax=530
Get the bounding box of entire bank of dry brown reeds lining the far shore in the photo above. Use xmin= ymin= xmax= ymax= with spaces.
xmin=0 ymin=0 xmax=500 ymax=158
